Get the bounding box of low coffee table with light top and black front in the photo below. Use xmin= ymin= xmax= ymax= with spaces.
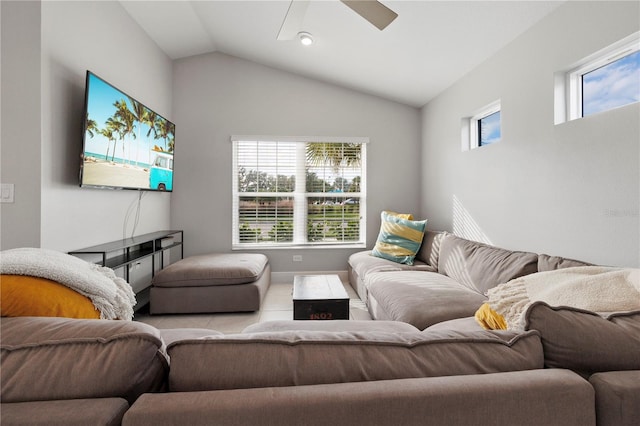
xmin=293 ymin=275 xmax=349 ymax=320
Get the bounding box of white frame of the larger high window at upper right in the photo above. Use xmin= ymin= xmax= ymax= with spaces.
xmin=554 ymin=31 xmax=640 ymax=124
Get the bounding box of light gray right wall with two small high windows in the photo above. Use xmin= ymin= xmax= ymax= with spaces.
xmin=421 ymin=1 xmax=640 ymax=266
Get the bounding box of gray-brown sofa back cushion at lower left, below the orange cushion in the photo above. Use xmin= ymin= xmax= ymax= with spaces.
xmin=0 ymin=317 xmax=168 ymax=403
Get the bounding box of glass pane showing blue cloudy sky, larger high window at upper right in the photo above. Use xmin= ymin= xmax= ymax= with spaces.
xmin=582 ymin=51 xmax=640 ymax=116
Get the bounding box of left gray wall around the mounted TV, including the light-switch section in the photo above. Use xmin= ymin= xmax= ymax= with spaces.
xmin=2 ymin=2 xmax=172 ymax=251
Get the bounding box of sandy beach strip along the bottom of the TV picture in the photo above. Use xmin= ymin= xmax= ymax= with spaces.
xmin=82 ymin=160 xmax=149 ymax=188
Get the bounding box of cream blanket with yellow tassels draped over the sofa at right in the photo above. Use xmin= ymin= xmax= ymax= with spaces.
xmin=487 ymin=266 xmax=640 ymax=330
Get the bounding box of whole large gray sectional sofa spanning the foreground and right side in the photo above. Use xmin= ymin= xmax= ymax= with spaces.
xmin=0 ymin=232 xmax=640 ymax=426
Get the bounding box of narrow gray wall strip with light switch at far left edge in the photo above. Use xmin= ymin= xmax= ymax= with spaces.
xmin=0 ymin=1 xmax=41 ymax=250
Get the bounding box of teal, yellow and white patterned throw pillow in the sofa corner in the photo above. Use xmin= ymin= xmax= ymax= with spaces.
xmin=371 ymin=211 xmax=427 ymax=265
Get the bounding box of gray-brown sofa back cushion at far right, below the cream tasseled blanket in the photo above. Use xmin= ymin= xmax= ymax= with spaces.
xmin=525 ymin=302 xmax=640 ymax=375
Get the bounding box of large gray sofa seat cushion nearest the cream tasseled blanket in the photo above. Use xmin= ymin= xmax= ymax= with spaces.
xmin=365 ymin=271 xmax=486 ymax=330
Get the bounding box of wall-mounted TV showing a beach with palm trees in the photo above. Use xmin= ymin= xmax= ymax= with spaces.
xmin=80 ymin=71 xmax=175 ymax=191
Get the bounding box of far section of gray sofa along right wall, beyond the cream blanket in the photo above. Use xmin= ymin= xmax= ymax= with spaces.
xmin=349 ymin=231 xmax=589 ymax=330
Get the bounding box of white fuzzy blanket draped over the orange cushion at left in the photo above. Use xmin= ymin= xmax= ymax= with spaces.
xmin=0 ymin=248 xmax=136 ymax=320
